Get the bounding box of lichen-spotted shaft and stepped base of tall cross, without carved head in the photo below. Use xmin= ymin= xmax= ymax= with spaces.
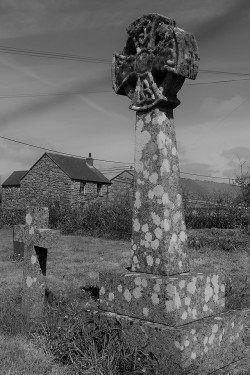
xmin=100 ymin=108 xmax=250 ymax=375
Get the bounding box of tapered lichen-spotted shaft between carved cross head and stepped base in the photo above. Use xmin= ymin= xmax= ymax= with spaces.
xmin=131 ymin=108 xmax=189 ymax=275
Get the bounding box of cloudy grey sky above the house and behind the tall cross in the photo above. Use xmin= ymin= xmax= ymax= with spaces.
xmin=0 ymin=0 xmax=250 ymax=182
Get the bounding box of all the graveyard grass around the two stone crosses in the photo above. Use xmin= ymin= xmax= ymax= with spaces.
xmin=0 ymin=225 xmax=249 ymax=375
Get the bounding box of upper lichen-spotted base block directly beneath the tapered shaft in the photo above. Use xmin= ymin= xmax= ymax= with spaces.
xmin=99 ymin=271 xmax=225 ymax=325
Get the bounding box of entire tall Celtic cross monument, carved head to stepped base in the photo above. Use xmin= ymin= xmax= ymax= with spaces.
xmin=97 ymin=14 xmax=250 ymax=375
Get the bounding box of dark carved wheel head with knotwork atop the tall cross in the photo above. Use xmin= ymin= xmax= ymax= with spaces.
xmin=112 ymin=14 xmax=199 ymax=111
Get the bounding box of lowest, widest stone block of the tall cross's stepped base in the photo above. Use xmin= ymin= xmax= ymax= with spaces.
xmin=97 ymin=310 xmax=249 ymax=375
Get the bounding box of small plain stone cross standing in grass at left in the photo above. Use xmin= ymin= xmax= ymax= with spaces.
xmin=14 ymin=207 xmax=59 ymax=319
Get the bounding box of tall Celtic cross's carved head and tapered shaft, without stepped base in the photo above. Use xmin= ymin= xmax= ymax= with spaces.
xmin=112 ymin=14 xmax=199 ymax=275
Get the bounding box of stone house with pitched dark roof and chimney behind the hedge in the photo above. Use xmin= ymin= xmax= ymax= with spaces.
xmin=2 ymin=152 xmax=111 ymax=209
